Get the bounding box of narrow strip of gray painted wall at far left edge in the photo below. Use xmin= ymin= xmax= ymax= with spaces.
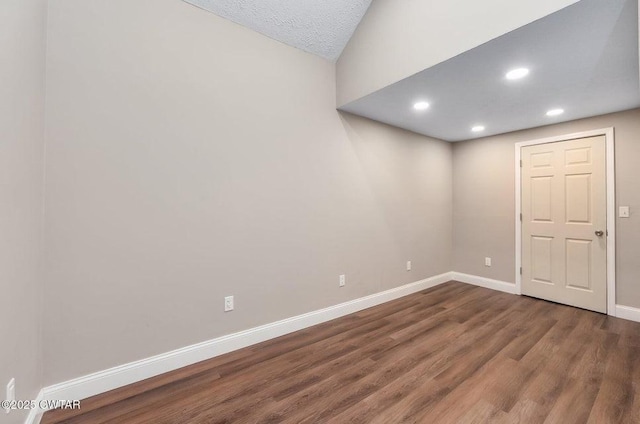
xmin=0 ymin=0 xmax=46 ymax=423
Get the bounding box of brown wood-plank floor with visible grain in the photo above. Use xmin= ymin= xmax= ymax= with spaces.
xmin=42 ymin=282 xmax=640 ymax=424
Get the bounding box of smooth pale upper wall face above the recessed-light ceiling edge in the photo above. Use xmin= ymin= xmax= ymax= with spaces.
xmin=336 ymin=0 xmax=580 ymax=106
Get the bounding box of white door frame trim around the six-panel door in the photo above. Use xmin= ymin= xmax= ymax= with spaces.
xmin=515 ymin=127 xmax=616 ymax=316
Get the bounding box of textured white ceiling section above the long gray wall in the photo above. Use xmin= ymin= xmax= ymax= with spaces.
xmin=184 ymin=0 xmax=371 ymax=62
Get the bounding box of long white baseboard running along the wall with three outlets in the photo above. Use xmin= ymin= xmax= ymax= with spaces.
xmin=38 ymin=272 xmax=453 ymax=400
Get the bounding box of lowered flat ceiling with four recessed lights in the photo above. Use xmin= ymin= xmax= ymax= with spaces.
xmin=341 ymin=0 xmax=640 ymax=141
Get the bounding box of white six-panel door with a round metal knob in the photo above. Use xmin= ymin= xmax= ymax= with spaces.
xmin=521 ymin=136 xmax=607 ymax=313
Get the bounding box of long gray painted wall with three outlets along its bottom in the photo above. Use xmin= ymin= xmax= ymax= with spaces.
xmin=44 ymin=0 xmax=452 ymax=384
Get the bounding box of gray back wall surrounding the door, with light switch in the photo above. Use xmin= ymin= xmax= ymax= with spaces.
xmin=453 ymin=109 xmax=640 ymax=308
